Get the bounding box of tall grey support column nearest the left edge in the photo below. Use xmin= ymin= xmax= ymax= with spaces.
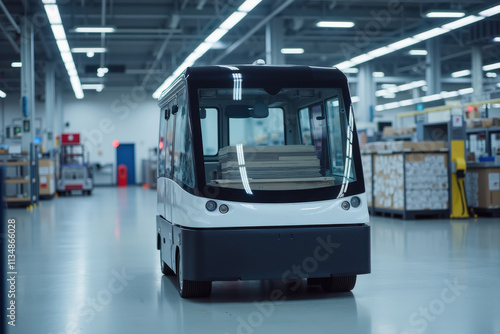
xmin=21 ymin=18 xmax=35 ymax=151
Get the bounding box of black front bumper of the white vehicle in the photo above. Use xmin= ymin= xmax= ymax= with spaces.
xmin=173 ymin=224 xmax=371 ymax=281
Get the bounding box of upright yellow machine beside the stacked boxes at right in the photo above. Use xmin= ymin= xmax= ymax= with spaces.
xmin=450 ymin=140 xmax=470 ymax=218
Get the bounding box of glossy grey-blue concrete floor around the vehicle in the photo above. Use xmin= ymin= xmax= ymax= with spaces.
xmin=8 ymin=187 xmax=500 ymax=334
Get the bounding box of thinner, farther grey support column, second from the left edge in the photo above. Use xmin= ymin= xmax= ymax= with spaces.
xmin=44 ymin=62 xmax=56 ymax=152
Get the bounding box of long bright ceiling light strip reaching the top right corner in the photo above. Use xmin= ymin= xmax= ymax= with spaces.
xmin=334 ymin=5 xmax=500 ymax=70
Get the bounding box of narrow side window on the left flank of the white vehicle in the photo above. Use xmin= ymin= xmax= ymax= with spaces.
xmin=174 ymin=93 xmax=195 ymax=188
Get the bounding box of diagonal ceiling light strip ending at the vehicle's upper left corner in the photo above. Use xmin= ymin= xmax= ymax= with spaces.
xmin=153 ymin=0 xmax=262 ymax=99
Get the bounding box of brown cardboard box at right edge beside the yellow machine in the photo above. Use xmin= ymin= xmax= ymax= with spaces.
xmin=467 ymin=167 xmax=500 ymax=209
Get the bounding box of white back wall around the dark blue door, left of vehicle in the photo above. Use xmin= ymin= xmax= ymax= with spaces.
xmin=63 ymin=88 xmax=160 ymax=182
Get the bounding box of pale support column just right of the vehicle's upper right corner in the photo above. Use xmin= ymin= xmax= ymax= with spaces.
xmin=354 ymin=62 xmax=377 ymax=122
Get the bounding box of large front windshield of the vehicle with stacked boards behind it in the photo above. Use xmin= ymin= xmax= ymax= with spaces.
xmin=198 ymin=87 xmax=356 ymax=194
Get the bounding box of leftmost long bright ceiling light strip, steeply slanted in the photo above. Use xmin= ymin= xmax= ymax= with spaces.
xmin=42 ymin=0 xmax=84 ymax=99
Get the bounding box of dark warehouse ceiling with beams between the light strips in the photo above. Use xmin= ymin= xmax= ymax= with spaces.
xmin=0 ymin=0 xmax=500 ymax=102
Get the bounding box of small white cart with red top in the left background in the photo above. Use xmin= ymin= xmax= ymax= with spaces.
xmin=57 ymin=134 xmax=94 ymax=195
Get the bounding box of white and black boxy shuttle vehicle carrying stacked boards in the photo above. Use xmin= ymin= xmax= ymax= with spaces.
xmin=156 ymin=66 xmax=370 ymax=297
